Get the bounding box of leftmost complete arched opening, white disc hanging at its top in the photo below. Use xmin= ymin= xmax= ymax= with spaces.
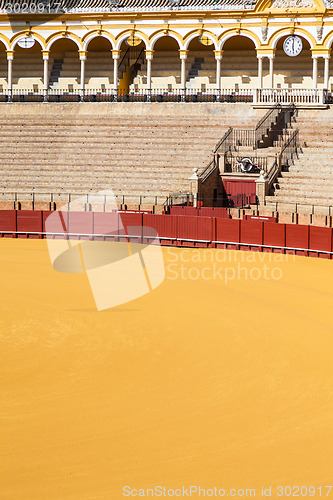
xmin=12 ymin=36 xmax=43 ymax=93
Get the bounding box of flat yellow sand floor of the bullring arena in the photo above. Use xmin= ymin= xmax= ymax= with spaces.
xmin=0 ymin=240 xmax=333 ymax=500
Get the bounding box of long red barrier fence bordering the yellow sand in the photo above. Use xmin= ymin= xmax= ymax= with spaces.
xmin=0 ymin=210 xmax=333 ymax=259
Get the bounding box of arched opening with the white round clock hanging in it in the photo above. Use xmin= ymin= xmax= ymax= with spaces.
xmin=272 ymin=35 xmax=312 ymax=89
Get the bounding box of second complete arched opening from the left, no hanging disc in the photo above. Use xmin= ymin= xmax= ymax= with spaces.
xmin=49 ymin=38 xmax=80 ymax=92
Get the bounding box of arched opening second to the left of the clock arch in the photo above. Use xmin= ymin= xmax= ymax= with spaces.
xmin=186 ymin=35 xmax=216 ymax=92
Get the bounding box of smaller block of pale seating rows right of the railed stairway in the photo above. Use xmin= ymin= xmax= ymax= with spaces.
xmin=266 ymin=109 xmax=333 ymax=209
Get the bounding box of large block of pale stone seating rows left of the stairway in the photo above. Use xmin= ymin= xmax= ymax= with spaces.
xmin=0 ymin=103 xmax=262 ymax=205
